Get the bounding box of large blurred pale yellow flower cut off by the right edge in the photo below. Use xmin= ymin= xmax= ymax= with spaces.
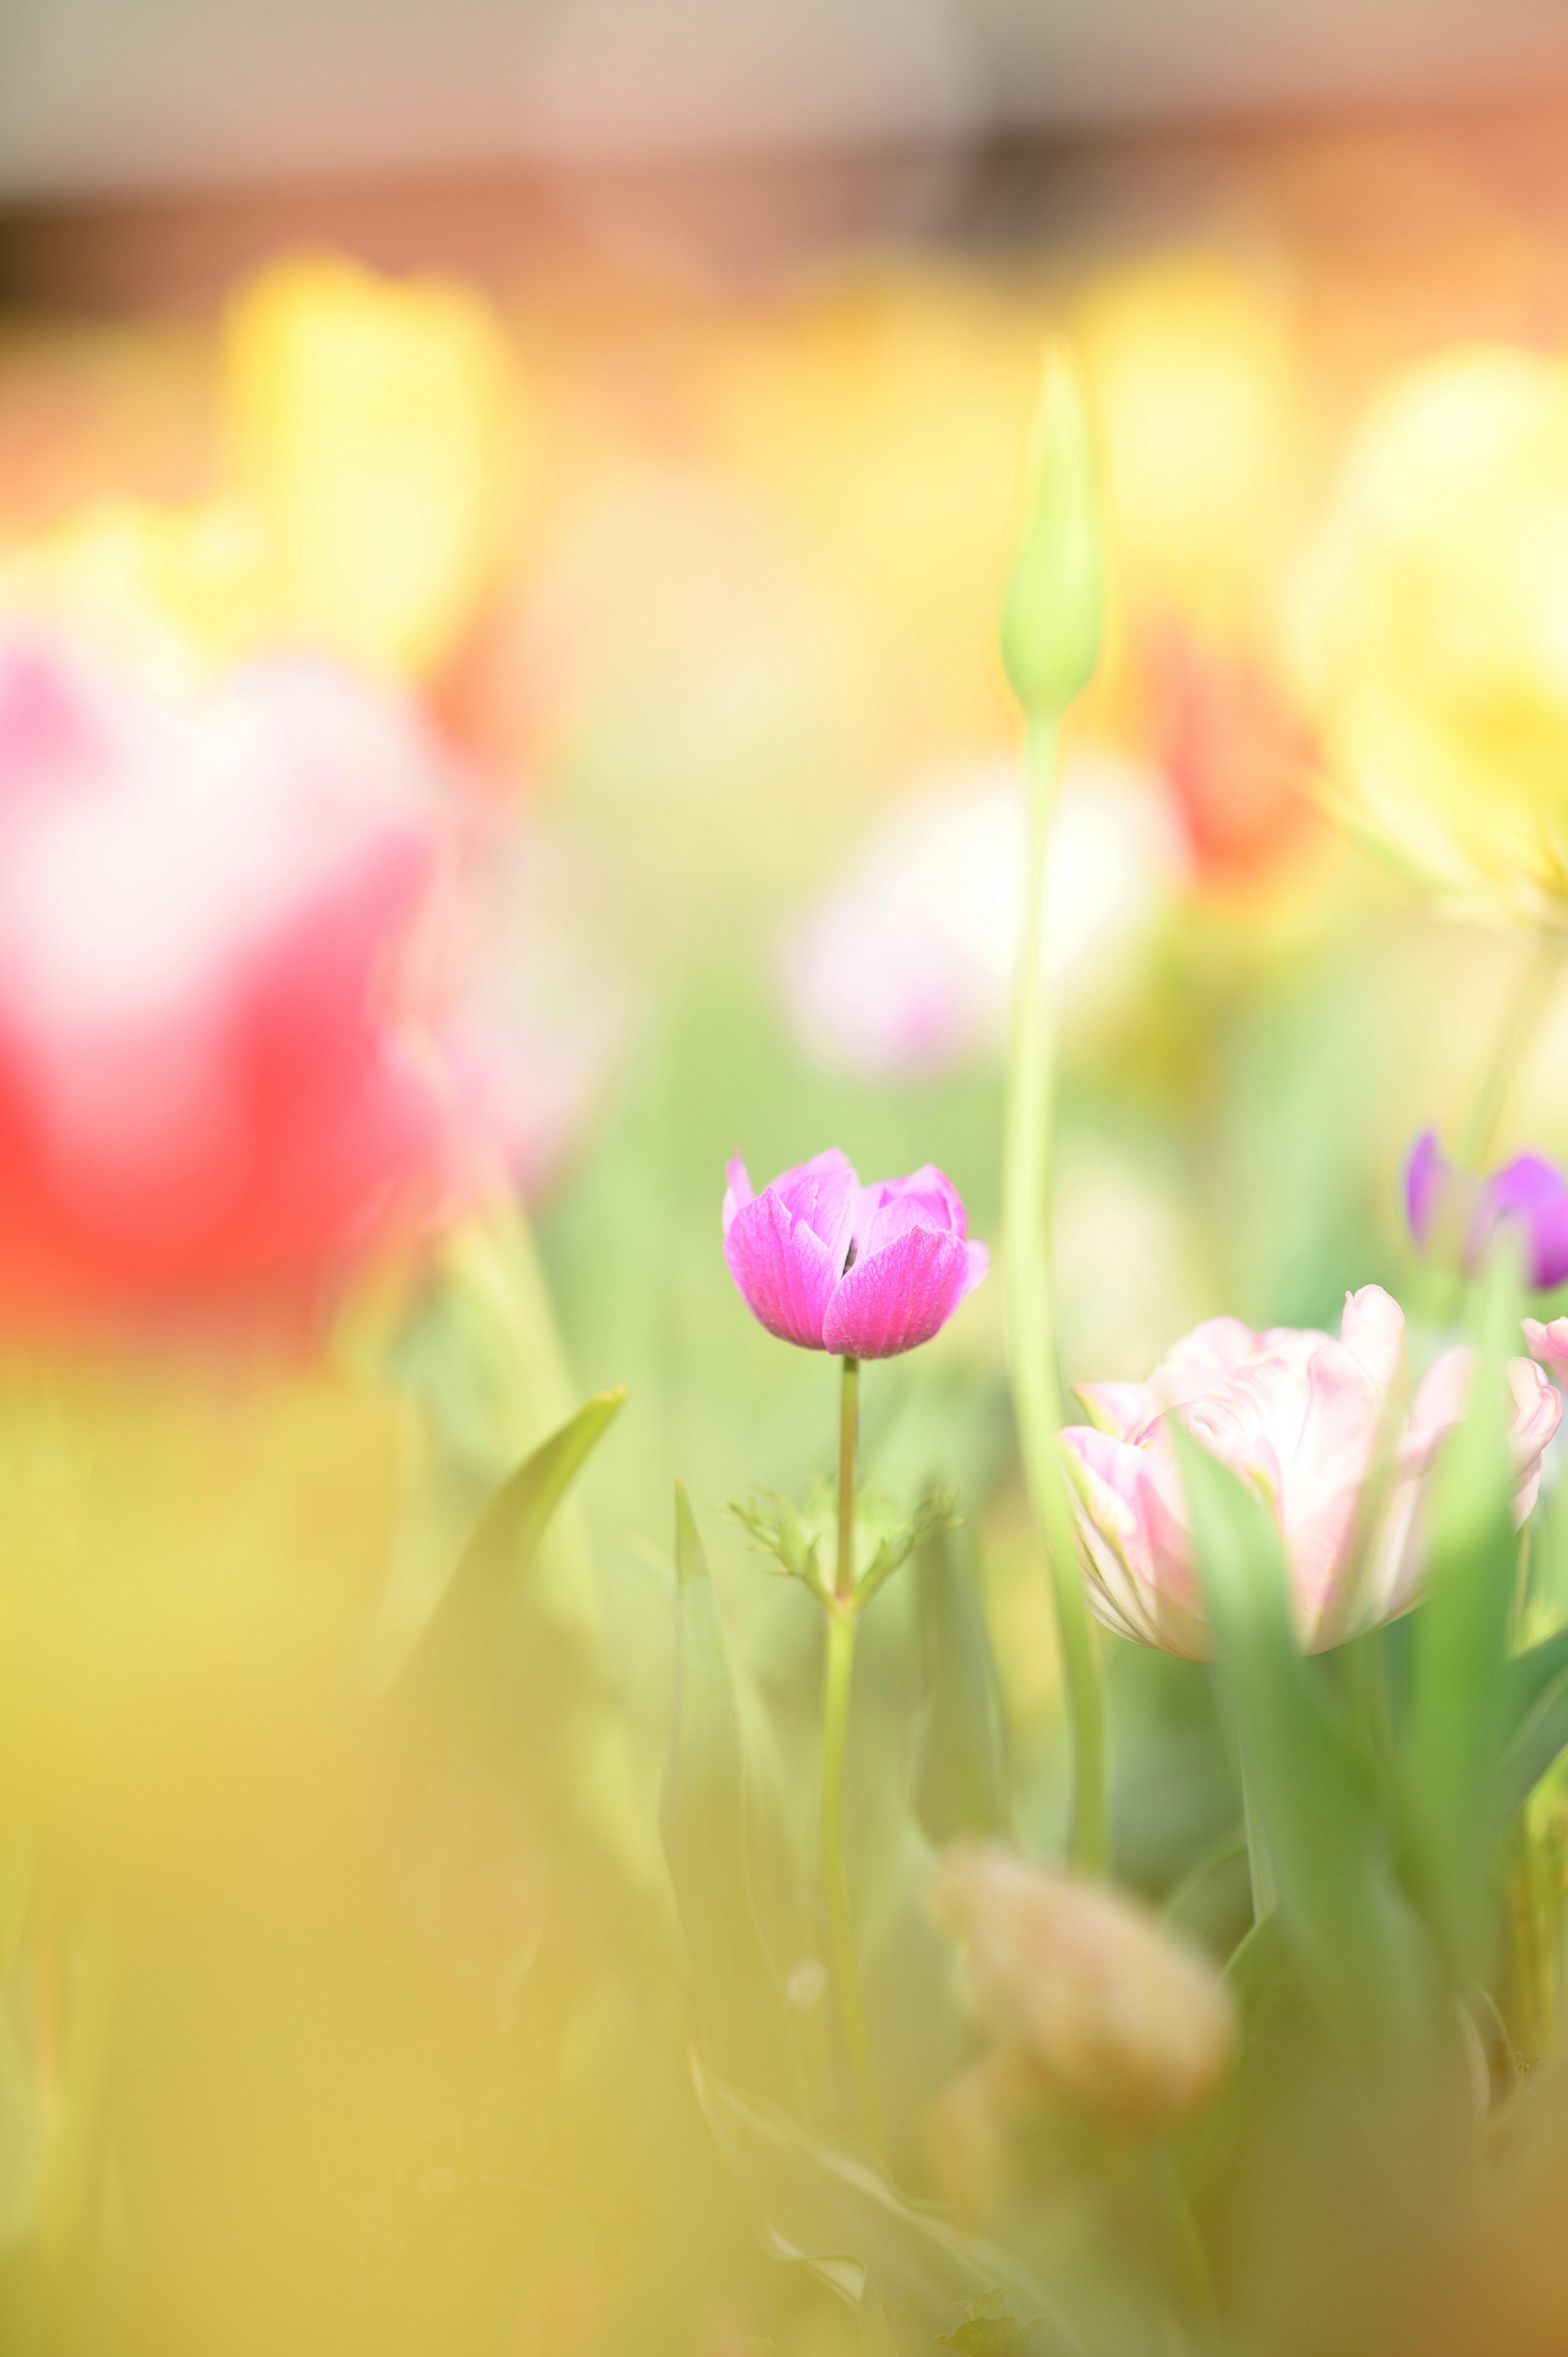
xmin=1292 ymin=346 xmax=1568 ymax=926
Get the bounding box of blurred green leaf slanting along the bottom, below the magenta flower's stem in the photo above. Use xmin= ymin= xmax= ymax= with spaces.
xmin=693 ymin=2065 xmax=1073 ymax=2357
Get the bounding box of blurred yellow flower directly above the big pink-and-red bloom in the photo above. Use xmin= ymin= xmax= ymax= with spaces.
xmin=224 ymin=254 xmax=517 ymax=679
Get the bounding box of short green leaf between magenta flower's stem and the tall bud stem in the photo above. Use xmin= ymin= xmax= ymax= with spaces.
xmin=915 ymin=1530 xmax=1011 ymax=1843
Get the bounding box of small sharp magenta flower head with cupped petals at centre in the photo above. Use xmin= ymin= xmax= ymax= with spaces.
xmin=724 ymin=1146 xmax=990 ymax=1358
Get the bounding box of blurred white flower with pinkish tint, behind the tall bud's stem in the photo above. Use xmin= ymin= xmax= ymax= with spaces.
xmin=783 ymin=747 xmax=1186 ymax=1075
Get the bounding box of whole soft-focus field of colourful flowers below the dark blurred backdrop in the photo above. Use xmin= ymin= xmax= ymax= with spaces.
xmin=0 ymin=119 xmax=1568 ymax=2357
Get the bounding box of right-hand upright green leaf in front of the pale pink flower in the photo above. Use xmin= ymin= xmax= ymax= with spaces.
xmin=1401 ymin=1254 xmax=1519 ymax=1982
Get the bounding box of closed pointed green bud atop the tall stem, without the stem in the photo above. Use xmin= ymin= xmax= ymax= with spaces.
xmin=1002 ymin=344 xmax=1106 ymax=721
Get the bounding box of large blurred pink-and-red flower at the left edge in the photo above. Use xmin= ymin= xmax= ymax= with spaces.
xmin=0 ymin=636 xmax=514 ymax=1318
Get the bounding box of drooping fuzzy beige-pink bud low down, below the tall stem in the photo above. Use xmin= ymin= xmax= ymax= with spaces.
xmin=934 ymin=1846 xmax=1236 ymax=2131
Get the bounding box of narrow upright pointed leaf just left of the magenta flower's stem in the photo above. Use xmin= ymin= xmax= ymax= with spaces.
xmin=660 ymin=1483 xmax=804 ymax=2105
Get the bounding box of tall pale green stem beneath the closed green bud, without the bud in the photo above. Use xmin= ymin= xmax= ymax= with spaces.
xmin=1002 ymin=719 xmax=1108 ymax=1874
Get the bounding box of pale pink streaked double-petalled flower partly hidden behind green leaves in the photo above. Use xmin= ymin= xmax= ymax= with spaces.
xmin=1061 ymin=1284 xmax=1563 ymax=1659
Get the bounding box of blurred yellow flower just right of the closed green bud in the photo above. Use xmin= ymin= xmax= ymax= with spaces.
xmin=1075 ymin=250 xmax=1306 ymax=641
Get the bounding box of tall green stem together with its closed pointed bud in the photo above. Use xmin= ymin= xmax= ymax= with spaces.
xmin=1002 ymin=346 xmax=1108 ymax=1874
